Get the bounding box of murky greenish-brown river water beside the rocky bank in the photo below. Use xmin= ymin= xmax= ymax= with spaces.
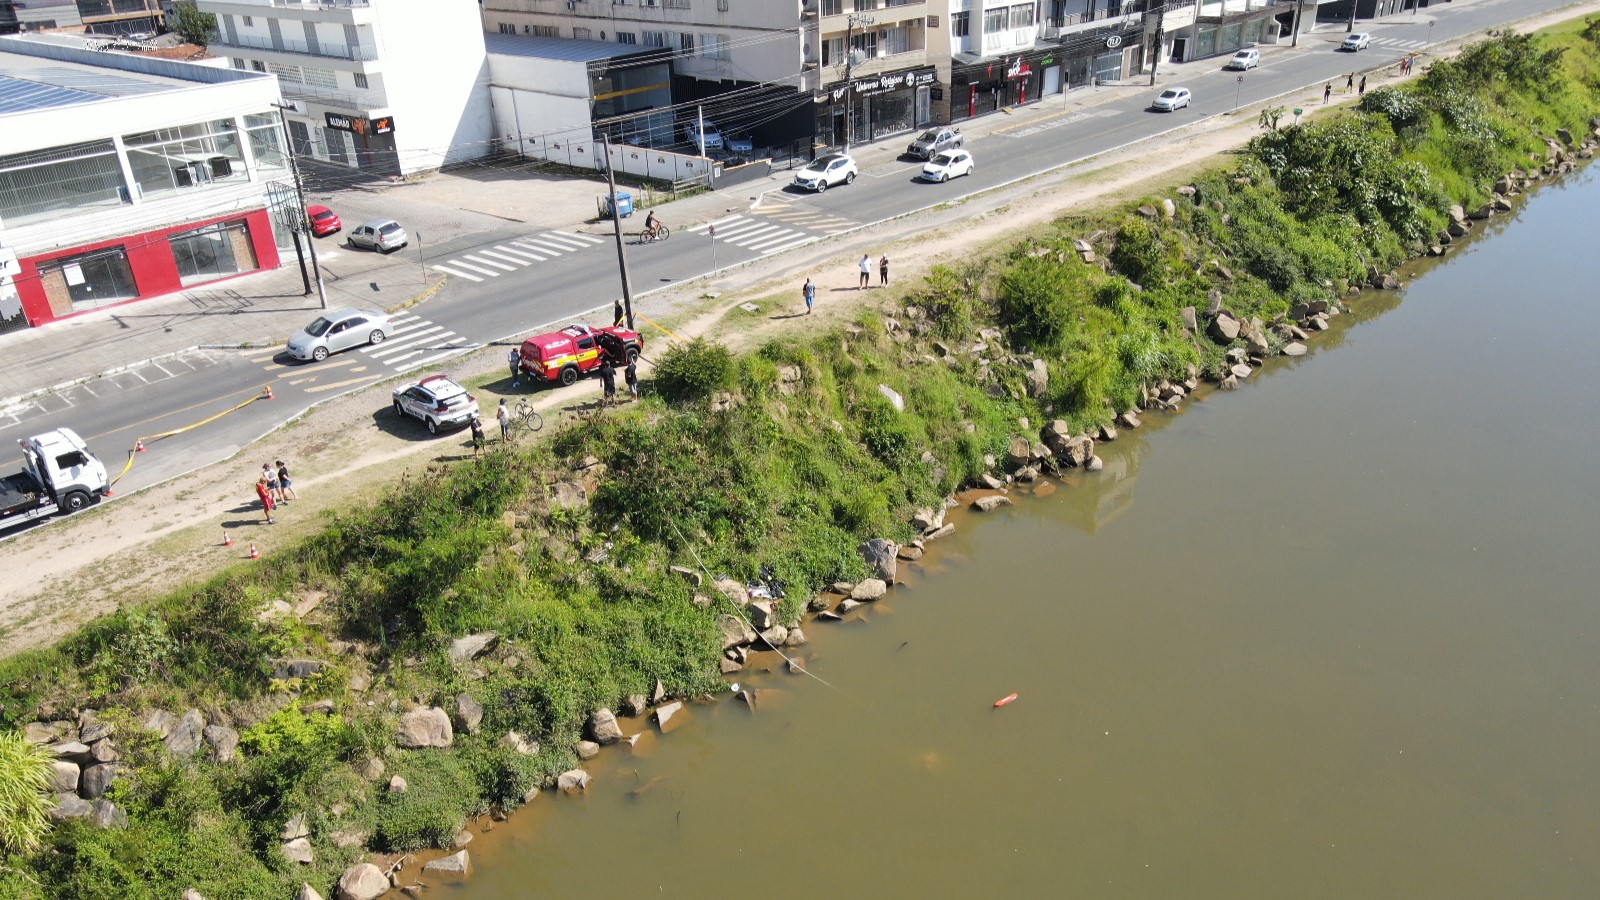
xmin=440 ymin=166 xmax=1600 ymax=900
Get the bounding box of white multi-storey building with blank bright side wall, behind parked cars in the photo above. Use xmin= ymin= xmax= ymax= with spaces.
xmin=198 ymin=0 xmax=493 ymax=176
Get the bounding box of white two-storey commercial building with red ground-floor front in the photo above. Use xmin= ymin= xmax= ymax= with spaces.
xmin=0 ymin=38 xmax=284 ymax=330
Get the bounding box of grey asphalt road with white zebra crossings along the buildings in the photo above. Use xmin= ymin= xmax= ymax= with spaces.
xmin=0 ymin=0 xmax=1568 ymax=531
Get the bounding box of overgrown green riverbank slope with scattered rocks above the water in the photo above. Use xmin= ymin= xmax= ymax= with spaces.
xmin=6 ymin=15 xmax=1592 ymax=897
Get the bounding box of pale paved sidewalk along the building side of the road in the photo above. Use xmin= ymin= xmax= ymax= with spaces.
xmin=0 ymin=26 xmax=1350 ymax=408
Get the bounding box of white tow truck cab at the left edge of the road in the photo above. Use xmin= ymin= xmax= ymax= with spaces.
xmin=0 ymin=428 xmax=110 ymax=530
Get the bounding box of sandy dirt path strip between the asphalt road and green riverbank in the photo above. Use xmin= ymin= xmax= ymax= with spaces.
xmin=0 ymin=3 xmax=1595 ymax=655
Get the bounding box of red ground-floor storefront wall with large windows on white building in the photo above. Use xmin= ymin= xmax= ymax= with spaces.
xmin=14 ymin=210 xmax=278 ymax=325
